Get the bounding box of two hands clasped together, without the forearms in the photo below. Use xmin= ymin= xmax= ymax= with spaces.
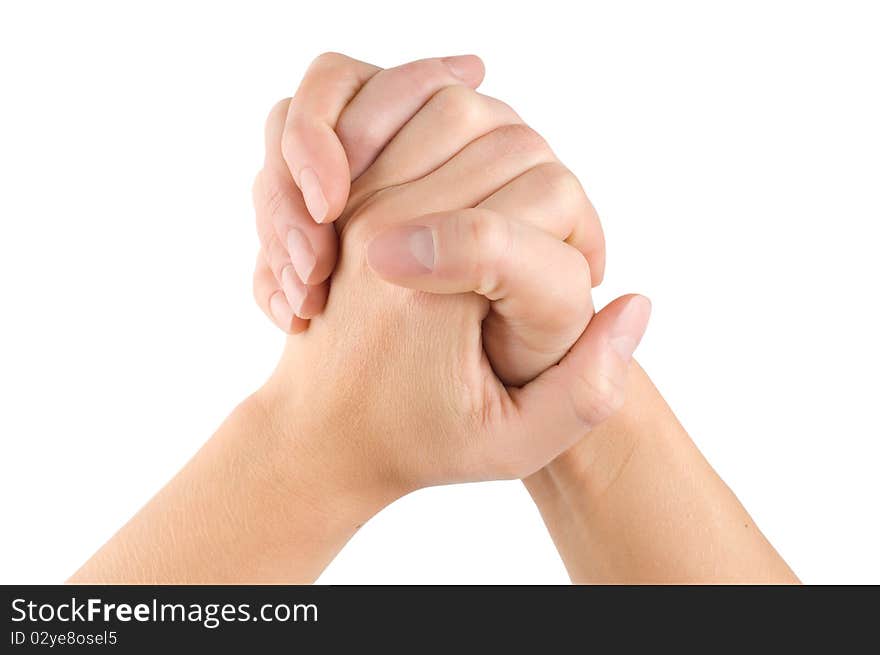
xmin=254 ymin=54 xmax=649 ymax=498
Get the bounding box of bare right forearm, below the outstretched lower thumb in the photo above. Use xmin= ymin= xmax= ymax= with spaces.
xmin=525 ymin=363 xmax=797 ymax=583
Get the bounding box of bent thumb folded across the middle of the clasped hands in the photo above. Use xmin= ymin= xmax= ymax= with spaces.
xmin=367 ymin=209 xmax=593 ymax=385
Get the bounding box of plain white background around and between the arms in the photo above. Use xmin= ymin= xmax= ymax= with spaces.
xmin=0 ymin=0 xmax=880 ymax=583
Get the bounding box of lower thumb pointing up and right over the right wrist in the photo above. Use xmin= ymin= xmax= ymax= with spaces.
xmin=498 ymin=295 xmax=651 ymax=477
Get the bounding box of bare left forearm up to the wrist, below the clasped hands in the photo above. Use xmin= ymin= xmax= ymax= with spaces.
xmin=70 ymin=384 xmax=392 ymax=584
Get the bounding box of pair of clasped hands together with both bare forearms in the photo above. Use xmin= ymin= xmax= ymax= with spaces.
xmin=72 ymin=55 xmax=797 ymax=583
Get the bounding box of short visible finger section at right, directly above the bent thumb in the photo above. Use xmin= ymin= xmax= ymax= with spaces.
xmin=478 ymin=161 xmax=605 ymax=287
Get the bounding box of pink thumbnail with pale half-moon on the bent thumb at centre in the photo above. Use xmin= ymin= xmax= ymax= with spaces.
xmin=367 ymin=225 xmax=434 ymax=277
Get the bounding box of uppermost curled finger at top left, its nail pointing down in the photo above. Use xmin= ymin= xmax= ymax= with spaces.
xmin=281 ymin=52 xmax=380 ymax=223
